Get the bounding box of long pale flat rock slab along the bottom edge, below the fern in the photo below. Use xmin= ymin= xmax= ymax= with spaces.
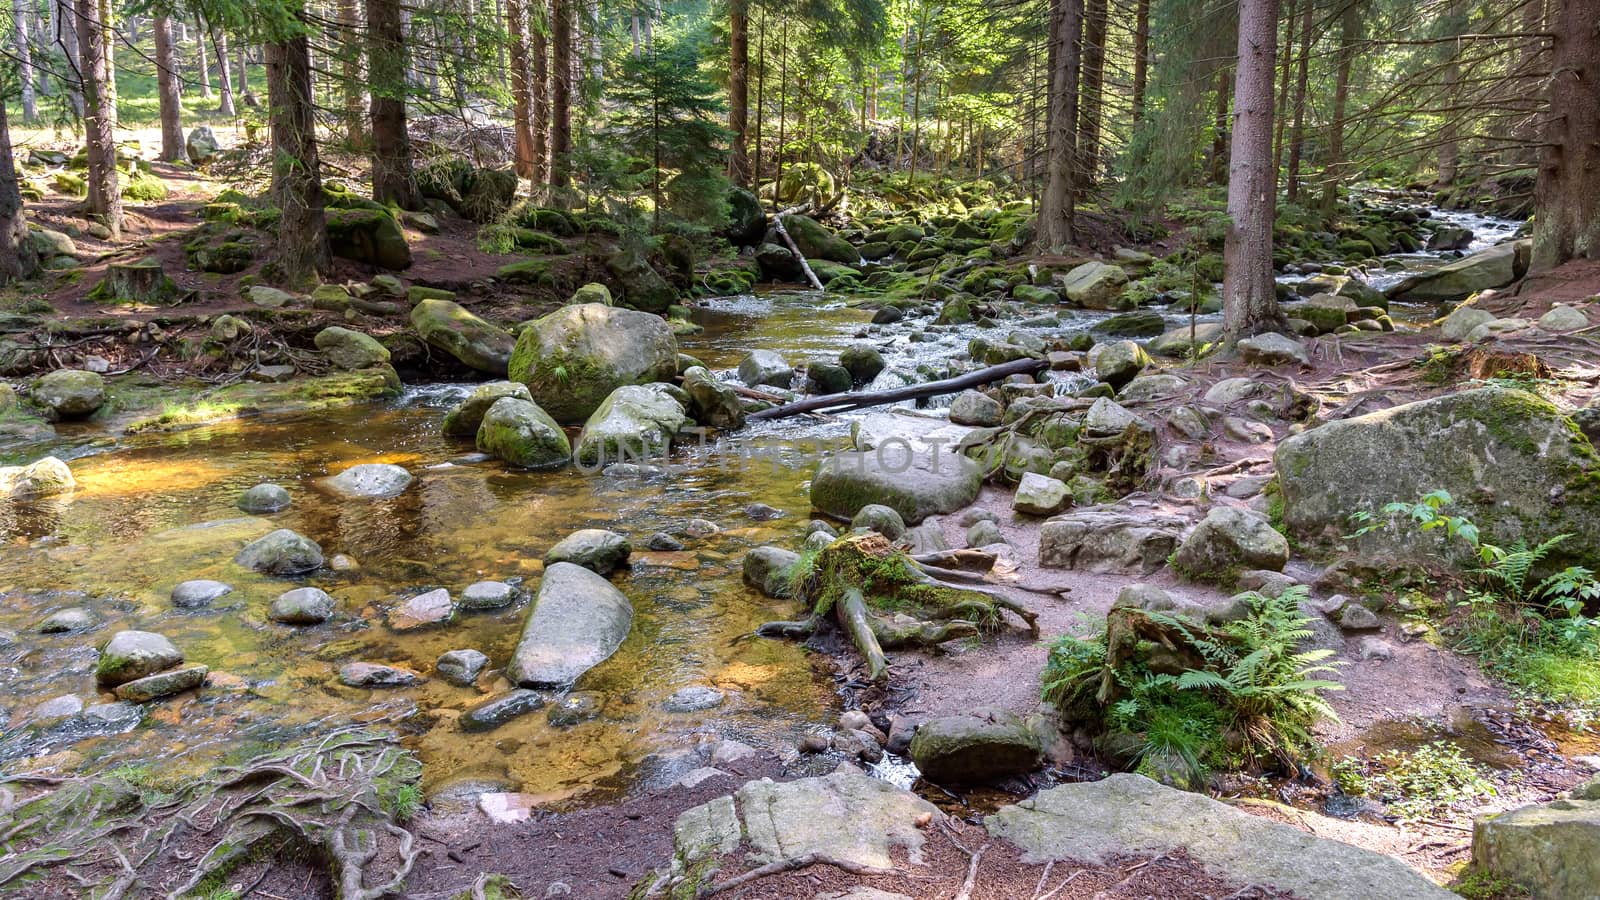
xmin=984 ymin=775 xmax=1454 ymax=900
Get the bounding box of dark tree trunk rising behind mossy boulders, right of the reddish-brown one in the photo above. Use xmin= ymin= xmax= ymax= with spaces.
xmin=366 ymin=0 xmax=422 ymax=210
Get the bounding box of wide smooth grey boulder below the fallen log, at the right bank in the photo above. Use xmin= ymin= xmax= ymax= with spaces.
xmin=811 ymin=445 xmax=984 ymax=524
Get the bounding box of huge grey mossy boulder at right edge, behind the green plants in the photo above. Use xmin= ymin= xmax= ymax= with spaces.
xmin=1275 ymin=386 xmax=1600 ymax=564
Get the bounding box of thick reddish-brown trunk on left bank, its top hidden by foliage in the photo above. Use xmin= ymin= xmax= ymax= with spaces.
xmin=267 ymin=35 xmax=330 ymax=288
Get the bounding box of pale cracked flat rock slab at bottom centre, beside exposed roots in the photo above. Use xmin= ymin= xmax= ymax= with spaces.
xmin=674 ymin=772 xmax=941 ymax=868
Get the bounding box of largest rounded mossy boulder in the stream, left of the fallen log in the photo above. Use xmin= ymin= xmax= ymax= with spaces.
xmin=509 ymin=303 xmax=678 ymax=424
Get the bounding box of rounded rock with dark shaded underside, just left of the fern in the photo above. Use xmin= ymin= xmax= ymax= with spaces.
xmin=910 ymin=709 xmax=1045 ymax=785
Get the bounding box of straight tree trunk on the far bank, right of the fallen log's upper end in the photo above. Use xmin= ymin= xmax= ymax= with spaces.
xmin=1038 ymin=0 xmax=1083 ymax=250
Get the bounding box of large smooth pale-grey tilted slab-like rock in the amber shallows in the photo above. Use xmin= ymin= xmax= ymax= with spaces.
xmin=506 ymin=562 xmax=634 ymax=687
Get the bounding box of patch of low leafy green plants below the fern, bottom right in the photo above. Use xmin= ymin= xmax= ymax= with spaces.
xmin=1333 ymin=740 xmax=1498 ymax=822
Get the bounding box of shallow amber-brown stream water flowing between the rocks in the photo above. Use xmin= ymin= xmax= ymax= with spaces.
xmin=0 ymin=203 xmax=1523 ymax=802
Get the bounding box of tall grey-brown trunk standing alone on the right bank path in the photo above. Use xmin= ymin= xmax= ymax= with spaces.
xmin=1222 ymin=0 xmax=1283 ymax=343
